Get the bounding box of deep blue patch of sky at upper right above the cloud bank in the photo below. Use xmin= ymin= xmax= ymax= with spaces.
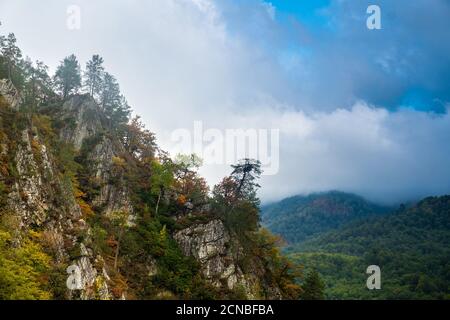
xmin=264 ymin=0 xmax=450 ymax=113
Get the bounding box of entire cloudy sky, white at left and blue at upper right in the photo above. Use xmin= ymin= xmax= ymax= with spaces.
xmin=0 ymin=0 xmax=450 ymax=204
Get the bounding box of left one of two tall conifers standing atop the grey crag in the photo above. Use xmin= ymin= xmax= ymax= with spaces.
xmin=54 ymin=54 xmax=81 ymax=99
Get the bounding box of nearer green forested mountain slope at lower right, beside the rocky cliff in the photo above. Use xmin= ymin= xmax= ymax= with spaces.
xmin=287 ymin=196 xmax=450 ymax=299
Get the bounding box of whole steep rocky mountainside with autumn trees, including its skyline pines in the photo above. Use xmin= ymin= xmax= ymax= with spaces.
xmin=0 ymin=34 xmax=301 ymax=299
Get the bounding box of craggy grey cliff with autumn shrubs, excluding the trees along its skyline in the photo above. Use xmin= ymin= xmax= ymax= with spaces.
xmin=0 ymin=88 xmax=302 ymax=299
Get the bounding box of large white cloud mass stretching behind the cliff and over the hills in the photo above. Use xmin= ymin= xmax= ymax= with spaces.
xmin=0 ymin=0 xmax=450 ymax=202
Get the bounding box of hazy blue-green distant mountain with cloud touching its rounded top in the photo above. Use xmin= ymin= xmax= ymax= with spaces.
xmin=261 ymin=191 xmax=389 ymax=244
